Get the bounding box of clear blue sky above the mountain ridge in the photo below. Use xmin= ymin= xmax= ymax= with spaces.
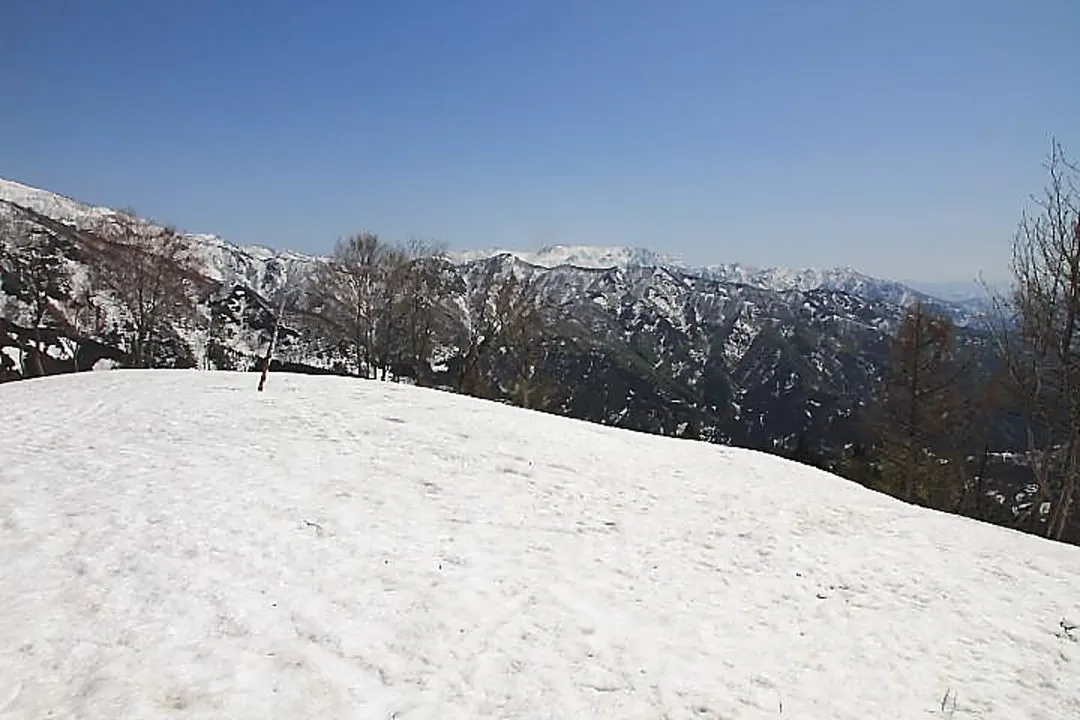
xmin=0 ymin=0 xmax=1080 ymax=281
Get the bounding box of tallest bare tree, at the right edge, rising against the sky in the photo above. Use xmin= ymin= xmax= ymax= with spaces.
xmin=1000 ymin=140 xmax=1080 ymax=540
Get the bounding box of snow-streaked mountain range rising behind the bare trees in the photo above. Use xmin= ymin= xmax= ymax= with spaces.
xmin=0 ymin=174 xmax=997 ymax=459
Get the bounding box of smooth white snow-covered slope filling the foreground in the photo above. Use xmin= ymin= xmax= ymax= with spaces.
xmin=0 ymin=370 xmax=1080 ymax=720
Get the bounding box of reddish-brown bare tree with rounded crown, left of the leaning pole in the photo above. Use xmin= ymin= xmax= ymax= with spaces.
xmin=92 ymin=214 xmax=195 ymax=367
